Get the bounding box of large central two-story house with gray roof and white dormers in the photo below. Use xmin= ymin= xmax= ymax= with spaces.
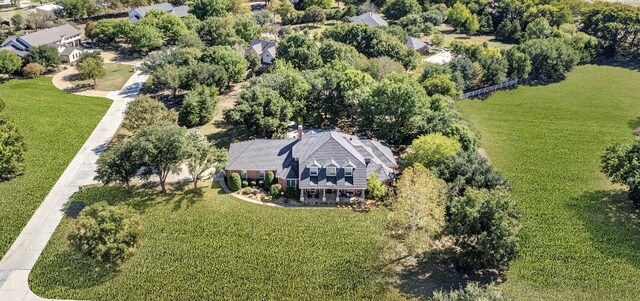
xmin=226 ymin=126 xmax=398 ymax=204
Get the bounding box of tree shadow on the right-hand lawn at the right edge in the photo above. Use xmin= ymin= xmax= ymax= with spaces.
xmin=569 ymin=190 xmax=640 ymax=268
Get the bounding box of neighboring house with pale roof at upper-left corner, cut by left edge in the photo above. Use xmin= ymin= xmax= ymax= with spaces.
xmin=0 ymin=24 xmax=82 ymax=62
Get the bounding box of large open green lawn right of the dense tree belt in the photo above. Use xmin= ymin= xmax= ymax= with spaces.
xmin=458 ymin=65 xmax=640 ymax=300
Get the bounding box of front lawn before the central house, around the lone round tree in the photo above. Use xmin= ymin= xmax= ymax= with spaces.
xmin=30 ymin=187 xmax=385 ymax=300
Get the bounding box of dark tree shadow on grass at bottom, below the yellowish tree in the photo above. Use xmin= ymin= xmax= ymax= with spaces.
xmin=395 ymin=250 xmax=499 ymax=300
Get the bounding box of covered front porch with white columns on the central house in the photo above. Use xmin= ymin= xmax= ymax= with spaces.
xmin=300 ymin=188 xmax=365 ymax=205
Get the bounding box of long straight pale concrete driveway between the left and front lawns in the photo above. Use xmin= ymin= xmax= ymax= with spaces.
xmin=0 ymin=72 xmax=148 ymax=301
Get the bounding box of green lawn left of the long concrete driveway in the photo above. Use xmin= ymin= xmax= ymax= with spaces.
xmin=0 ymin=77 xmax=111 ymax=257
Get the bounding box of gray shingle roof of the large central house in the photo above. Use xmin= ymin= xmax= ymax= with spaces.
xmin=226 ymin=131 xmax=397 ymax=189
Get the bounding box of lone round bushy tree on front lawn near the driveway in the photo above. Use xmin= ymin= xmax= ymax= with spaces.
xmin=69 ymin=202 xmax=140 ymax=264
